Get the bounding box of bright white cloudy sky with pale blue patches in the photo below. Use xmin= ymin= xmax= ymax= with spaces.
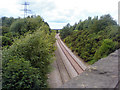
xmin=0 ymin=0 xmax=119 ymax=29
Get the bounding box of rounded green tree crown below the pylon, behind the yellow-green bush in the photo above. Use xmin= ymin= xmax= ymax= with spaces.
xmin=10 ymin=16 xmax=44 ymax=35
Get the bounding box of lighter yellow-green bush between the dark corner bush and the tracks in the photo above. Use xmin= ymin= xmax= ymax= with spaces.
xmin=6 ymin=31 xmax=54 ymax=68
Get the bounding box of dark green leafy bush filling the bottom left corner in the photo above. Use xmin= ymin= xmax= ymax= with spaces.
xmin=3 ymin=57 xmax=46 ymax=90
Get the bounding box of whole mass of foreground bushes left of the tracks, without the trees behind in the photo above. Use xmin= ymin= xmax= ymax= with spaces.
xmin=2 ymin=30 xmax=55 ymax=89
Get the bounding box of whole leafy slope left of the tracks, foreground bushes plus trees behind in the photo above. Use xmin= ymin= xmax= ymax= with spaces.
xmin=2 ymin=16 xmax=55 ymax=89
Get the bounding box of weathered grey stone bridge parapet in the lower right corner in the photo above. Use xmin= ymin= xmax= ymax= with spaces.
xmin=60 ymin=50 xmax=120 ymax=88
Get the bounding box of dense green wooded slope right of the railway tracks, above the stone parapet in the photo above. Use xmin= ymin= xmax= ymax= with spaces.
xmin=60 ymin=14 xmax=120 ymax=64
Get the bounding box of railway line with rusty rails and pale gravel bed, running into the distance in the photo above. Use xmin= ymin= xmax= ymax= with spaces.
xmin=49 ymin=34 xmax=86 ymax=88
